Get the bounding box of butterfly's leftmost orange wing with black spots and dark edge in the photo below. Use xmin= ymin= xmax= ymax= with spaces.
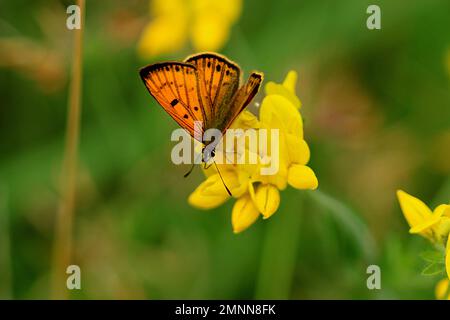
xmin=140 ymin=62 xmax=205 ymax=140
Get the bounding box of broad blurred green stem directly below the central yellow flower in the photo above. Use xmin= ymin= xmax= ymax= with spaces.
xmin=255 ymin=191 xmax=303 ymax=299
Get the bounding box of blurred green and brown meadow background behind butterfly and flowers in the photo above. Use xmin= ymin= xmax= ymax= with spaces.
xmin=0 ymin=0 xmax=450 ymax=299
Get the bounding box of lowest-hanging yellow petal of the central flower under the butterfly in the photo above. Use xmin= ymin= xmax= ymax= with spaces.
xmin=231 ymin=194 xmax=259 ymax=233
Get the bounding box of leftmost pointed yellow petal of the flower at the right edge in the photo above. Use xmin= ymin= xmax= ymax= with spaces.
xmin=397 ymin=190 xmax=432 ymax=232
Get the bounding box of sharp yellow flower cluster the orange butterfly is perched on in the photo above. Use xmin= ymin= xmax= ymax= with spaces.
xmin=188 ymin=71 xmax=318 ymax=233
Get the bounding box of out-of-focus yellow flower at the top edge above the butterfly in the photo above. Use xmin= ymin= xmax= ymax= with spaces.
xmin=138 ymin=0 xmax=242 ymax=58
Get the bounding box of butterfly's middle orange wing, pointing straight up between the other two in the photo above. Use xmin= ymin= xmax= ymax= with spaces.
xmin=185 ymin=53 xmax=240 ymax=131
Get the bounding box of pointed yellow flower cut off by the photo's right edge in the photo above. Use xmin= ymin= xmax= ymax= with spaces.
xmin=397 ymin=190 xmax=450 ymax=278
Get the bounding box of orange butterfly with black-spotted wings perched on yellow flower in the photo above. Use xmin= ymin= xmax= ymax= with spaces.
xmin=139 ymin=52 xmax=263 ymax=191
